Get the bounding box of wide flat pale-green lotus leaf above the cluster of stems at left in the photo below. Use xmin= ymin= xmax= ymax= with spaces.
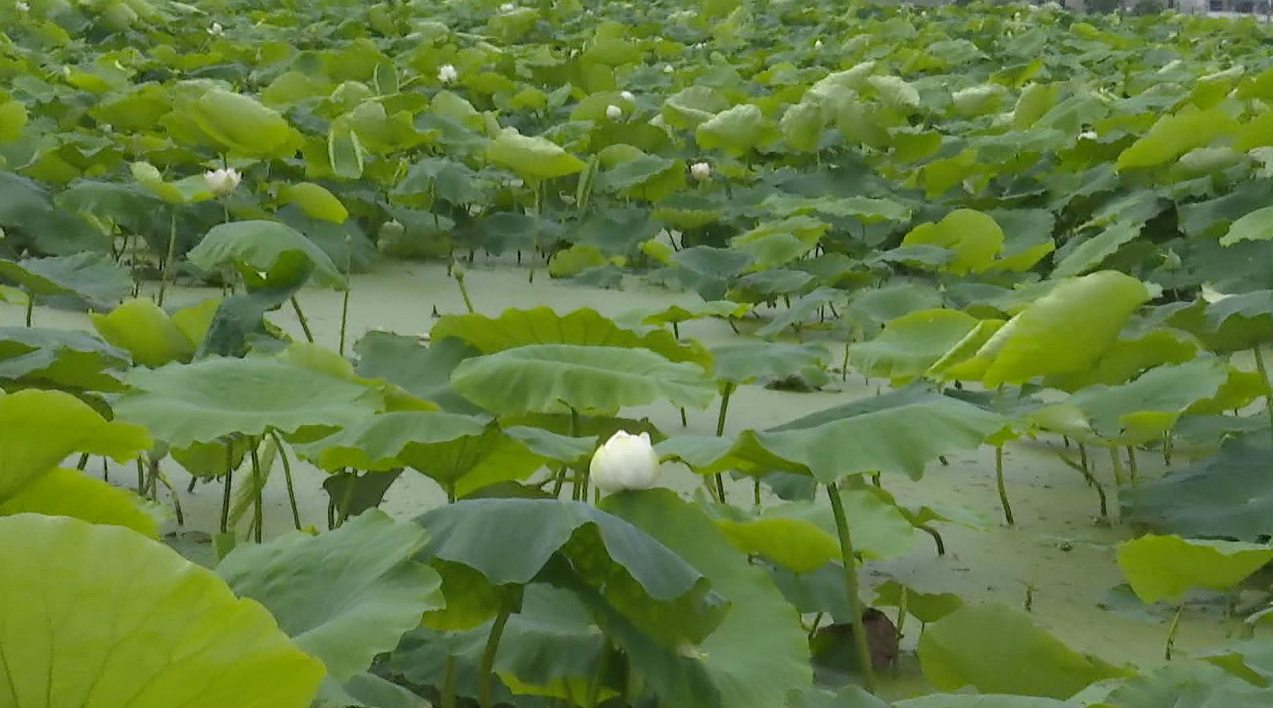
xmin=115 ymin=357 xmax=383 ymax=447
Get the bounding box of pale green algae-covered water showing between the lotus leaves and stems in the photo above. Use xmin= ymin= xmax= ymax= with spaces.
xmin=0 ymin=262 xmax=1235 ymax=697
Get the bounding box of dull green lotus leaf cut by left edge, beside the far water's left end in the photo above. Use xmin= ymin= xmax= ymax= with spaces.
xmin=0 ymin=252 xmax=132 ymax=308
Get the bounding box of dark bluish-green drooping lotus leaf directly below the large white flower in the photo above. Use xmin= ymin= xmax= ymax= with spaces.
xmin=416 ymin=499 xmax=726 ymax=647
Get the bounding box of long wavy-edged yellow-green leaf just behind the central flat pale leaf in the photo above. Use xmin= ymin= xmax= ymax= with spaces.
xmin=429 ymin=307 xmax=712 ymax=367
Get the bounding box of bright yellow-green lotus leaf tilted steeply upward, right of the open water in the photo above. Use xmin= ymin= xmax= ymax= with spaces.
xmin=975 ymin=270 xmax=1150 ymax=388
